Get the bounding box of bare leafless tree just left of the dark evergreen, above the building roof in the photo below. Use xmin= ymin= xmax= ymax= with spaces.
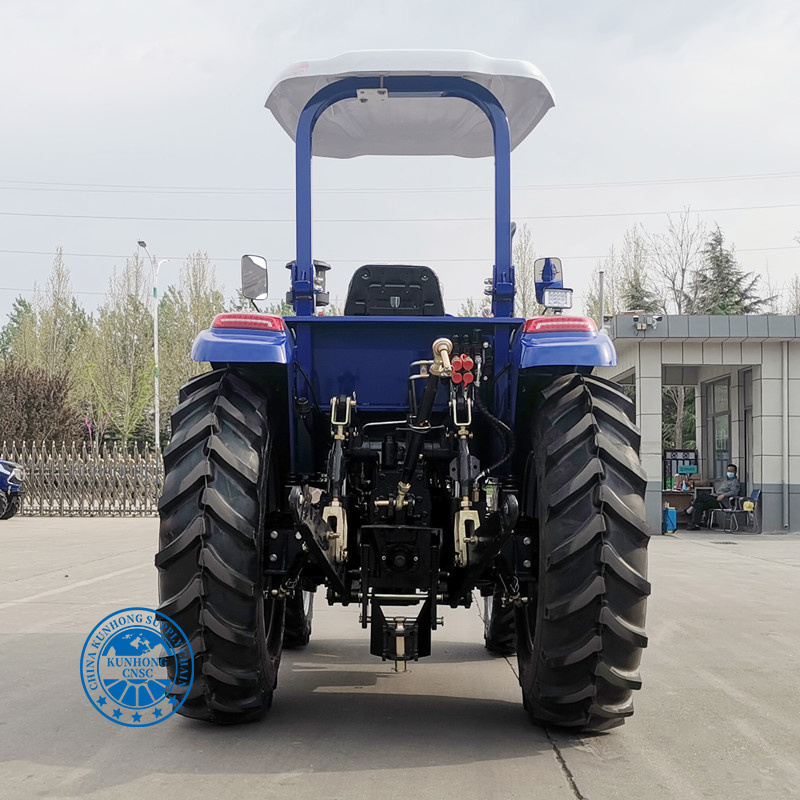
xmin=645 ymin=208 xmax=708 ymax=314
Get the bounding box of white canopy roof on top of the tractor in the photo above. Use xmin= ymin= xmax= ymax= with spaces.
xmin=266 ymin=50 xmax=554 ymax=158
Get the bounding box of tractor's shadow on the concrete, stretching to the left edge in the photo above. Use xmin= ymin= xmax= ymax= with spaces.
xmin=0 ymin=634 xmax=564 ymax=796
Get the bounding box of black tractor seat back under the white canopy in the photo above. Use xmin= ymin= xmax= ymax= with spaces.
xmin=344 ymin=264 xmax=444 ymax=317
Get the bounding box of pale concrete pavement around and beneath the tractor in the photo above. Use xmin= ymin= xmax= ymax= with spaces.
xmin=0 ymin=518 xmax=800 ymax=800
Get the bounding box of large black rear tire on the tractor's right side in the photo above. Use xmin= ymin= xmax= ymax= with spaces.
xmin=516 ymin=374 xmax=650 ymax=731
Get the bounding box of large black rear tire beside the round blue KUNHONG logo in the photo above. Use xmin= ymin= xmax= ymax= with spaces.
xmin=156 ymin=369 xmax=285 ymax=724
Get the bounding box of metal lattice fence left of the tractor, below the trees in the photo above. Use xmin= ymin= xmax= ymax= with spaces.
xmin=0 ymin=442 xmax=164 ymax=517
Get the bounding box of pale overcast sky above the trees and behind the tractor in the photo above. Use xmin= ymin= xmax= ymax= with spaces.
xmin=0 ymin=0 xmax=800 ymax=321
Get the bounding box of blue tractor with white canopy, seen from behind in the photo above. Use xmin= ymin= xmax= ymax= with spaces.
xmin=156 ymin=51 xmax=650 ymax=730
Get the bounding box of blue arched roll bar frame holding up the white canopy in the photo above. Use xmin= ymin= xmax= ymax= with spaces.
xmin=292 ymin=75 xmax=514 ymax=317
